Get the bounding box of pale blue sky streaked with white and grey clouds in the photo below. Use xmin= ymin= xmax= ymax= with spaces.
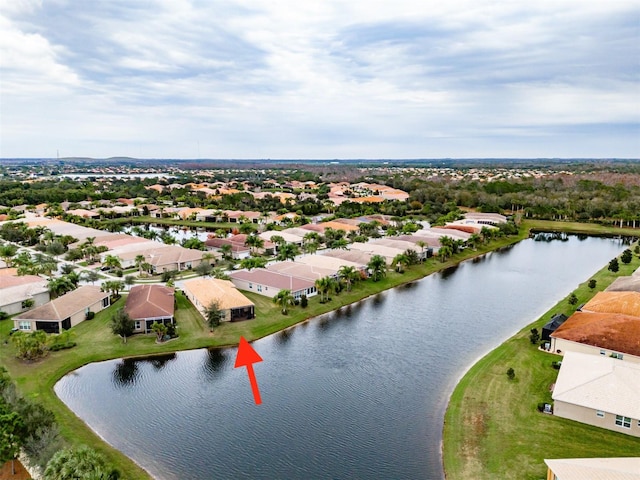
xmin=0 ymin=0 xmax=640 ymax=159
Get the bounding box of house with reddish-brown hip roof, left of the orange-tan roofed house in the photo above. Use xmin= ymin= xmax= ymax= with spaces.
xmin=124 ymin=285 xmax=175 ymax=333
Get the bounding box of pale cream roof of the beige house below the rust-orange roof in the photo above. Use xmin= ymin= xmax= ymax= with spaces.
xmin=552 ymin=352 xmax=640 ymax=419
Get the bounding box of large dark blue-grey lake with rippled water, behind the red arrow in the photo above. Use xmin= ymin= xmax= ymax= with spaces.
xmin=55 ymin=236 xmax=624 ymax=480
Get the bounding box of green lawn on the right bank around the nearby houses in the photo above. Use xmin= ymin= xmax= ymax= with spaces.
xmin=443 ymin=246 xmax=640 ymax=480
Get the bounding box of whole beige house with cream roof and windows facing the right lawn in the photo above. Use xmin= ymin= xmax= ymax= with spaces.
xmin=552 ymin=352 xmax=640 ymax=437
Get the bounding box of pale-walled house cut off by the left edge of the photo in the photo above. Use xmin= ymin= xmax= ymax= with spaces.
xmin=0 ymin=275 xmax=49 ymax=315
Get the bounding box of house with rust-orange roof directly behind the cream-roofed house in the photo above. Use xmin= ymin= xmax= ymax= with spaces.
xmin=549 ymin=312 xmax=640 ymax=363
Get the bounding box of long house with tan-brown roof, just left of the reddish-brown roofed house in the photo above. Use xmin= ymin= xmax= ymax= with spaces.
xmin=13 ymin=285 xmax=110 ymax=333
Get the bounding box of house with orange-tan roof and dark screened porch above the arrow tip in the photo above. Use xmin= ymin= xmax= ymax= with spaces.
xmin=182 ymin=278 xmax=255 ymax=322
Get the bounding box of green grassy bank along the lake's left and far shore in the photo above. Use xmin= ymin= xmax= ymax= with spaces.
xmin=0 ymin=221 xmax=639 ymax=480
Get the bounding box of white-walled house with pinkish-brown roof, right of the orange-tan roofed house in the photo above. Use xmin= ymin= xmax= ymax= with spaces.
xmin=229 ymin=268 xmax=318 ymax=299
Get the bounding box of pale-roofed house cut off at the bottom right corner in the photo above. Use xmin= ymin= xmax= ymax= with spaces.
xmin=544 ymin=457 xmax=640 ymax=480
